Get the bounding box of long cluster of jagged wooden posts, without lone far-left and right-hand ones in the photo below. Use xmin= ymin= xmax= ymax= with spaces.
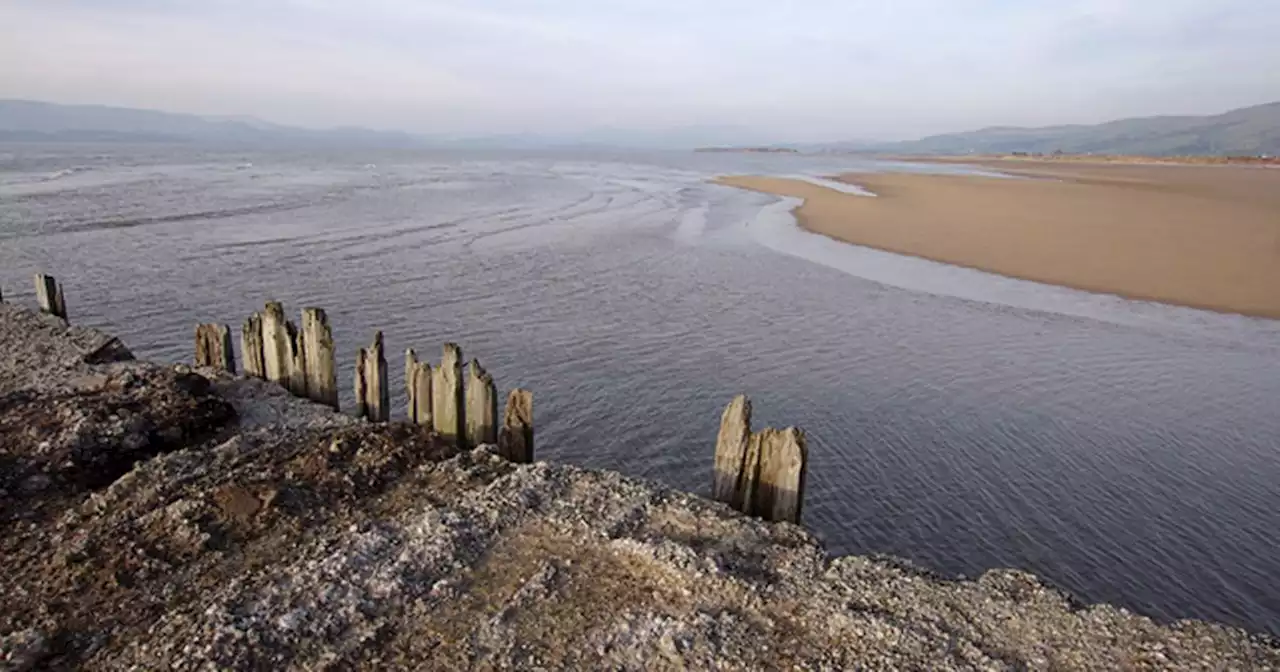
xmin=196 ymin=301 xmax=534 ymax=462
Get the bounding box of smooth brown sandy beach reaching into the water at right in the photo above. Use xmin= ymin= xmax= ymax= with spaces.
xmin=717 ymin=160 xmax=1280 ymax=317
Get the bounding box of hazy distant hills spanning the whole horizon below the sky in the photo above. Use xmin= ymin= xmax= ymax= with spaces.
xmin=0 ymin=100 xmax=1280 ymax=156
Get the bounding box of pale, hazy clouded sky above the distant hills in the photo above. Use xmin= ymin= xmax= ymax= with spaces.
xmin=0 ymin=0 xmax=1280 ymax=142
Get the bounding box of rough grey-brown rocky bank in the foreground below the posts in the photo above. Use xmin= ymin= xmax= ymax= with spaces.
xmin=0 ymin=306 xmax=1280 ymax=669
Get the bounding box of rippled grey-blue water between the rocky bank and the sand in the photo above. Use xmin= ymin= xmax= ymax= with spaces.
xmin=0 ymin=145 xmax=1280 ymax=634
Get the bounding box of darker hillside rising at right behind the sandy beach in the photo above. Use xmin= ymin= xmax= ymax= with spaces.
xmin=855 ymin=102 xmax=1280 ymax=156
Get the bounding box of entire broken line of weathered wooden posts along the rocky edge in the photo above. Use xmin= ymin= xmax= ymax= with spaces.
xmin=10 ymin=274 xmax=809 ymax=524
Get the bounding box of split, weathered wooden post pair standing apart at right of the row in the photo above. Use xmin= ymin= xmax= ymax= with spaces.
xmin=712 ymin=396 xmax=809 ymax=524
